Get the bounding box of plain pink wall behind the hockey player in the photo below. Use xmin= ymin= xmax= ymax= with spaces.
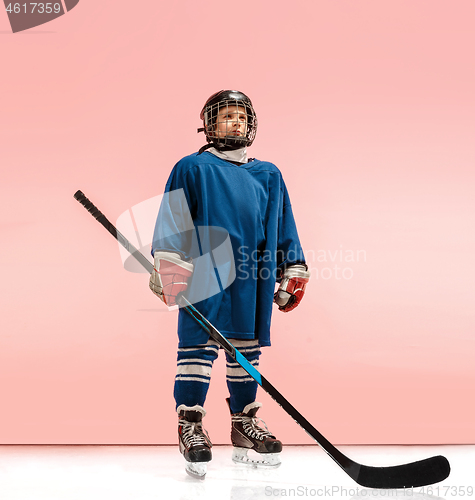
xmin=0 ymin=0 xmax=475 ymax=444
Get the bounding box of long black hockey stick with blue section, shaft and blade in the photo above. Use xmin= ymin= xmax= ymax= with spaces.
xmin=74 ymin=191 xmax=450 ymax=488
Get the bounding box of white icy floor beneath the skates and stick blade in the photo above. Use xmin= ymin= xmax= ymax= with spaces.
xmin=0 ymin=445 xmax=475 ymax=500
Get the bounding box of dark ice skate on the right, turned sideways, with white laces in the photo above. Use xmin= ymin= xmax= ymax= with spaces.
xmin=226 ymin=398 xmax=282 ymax=467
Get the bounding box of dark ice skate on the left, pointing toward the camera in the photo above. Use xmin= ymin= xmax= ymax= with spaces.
xmin=177 ymin=405 xmax=213 ymax=479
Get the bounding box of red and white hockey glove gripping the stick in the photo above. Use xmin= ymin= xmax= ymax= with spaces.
xmin=149 ymin=250 xmax=193 ymax=306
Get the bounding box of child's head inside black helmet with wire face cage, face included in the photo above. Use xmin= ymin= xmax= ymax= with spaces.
xmin=201 ymin=91 xmax=257 ymax=149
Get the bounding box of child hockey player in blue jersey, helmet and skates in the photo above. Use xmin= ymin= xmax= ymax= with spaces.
xmin=150 ymin=90 xmax=310 ymax=478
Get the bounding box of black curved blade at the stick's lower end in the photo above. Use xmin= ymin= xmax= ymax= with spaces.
xmin=353 ymin=455 xmax=450 ymax=488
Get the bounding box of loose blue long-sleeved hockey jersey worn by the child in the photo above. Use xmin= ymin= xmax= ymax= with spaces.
xmin=152 ymin=152 xmax=305 ymax=347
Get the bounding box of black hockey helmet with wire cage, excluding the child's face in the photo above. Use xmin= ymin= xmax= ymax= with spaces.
xmin=198 ymin=90 xmax=257 ymax=151
